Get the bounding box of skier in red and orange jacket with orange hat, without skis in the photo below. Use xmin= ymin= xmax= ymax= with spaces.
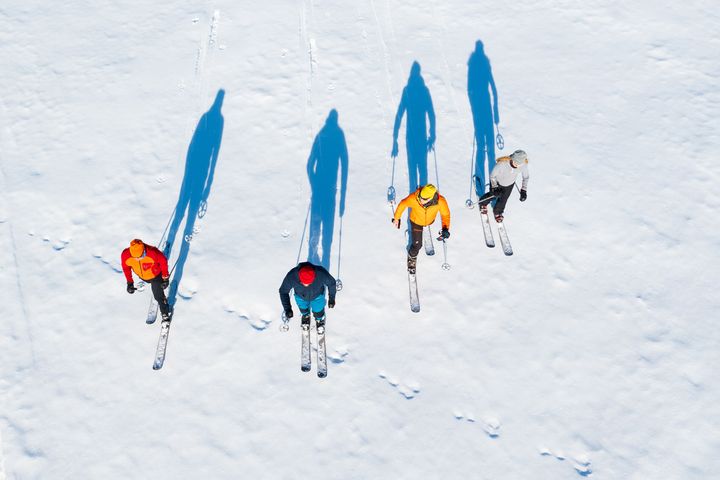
xmin=120 ymin=238 xmax=172 ymax=322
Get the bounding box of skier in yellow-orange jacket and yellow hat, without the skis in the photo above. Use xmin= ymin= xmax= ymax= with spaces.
xmin=392 ymin=183 xmax=450 ymax=273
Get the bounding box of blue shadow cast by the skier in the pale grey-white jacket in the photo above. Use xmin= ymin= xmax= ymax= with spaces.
xmin=468 ymin=40 xmax=500 ymax=197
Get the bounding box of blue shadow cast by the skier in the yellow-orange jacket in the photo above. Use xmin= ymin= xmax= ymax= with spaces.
xmin=392 ymin=62 xmax=435 ymax=192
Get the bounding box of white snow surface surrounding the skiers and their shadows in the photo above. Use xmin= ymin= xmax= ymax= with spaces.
xmin=0 ymin=0 xmax=720 ymax=480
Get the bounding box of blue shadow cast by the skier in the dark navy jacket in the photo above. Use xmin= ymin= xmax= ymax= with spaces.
xmin=307 ymin=109 xmax=348 ymax=270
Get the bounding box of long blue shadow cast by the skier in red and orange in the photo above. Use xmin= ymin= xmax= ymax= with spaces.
xmin=165 ymin=89 xmax=225 ymax=305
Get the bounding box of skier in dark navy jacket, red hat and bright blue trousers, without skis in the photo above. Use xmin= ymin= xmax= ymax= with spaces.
xmin=280 ymin=262 xmax=337 ymax=333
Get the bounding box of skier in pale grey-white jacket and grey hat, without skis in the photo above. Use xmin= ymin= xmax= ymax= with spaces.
xmin=478 ymin=150 xmax=530 ymax=222
